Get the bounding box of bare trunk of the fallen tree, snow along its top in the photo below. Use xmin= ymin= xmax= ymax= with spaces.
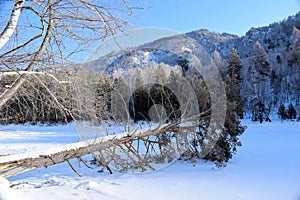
xmin=0 ymin=123 xmax=180 ymax=178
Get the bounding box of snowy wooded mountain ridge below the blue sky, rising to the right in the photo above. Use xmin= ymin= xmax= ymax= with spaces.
xmin=83 ymin=12 xmax=300 ymax=114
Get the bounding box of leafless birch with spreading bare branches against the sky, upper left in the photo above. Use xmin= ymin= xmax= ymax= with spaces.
xmin=0 ymin=0 xmax=139 ymax=121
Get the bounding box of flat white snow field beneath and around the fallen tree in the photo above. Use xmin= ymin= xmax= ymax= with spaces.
xmin=0 ymin=121 xmax=300 ymax=200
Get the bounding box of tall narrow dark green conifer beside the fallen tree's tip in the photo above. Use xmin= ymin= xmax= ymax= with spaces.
xmin=205 ymin=49 xmax=245 ymax=166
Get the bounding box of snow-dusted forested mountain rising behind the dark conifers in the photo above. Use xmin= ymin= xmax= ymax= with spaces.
xmin=91 ymin=12 xmax=300 ymax=117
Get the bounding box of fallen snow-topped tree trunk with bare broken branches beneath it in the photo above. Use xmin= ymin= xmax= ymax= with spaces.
xmin=0 ymin=112 xmax=209 ymax=178
